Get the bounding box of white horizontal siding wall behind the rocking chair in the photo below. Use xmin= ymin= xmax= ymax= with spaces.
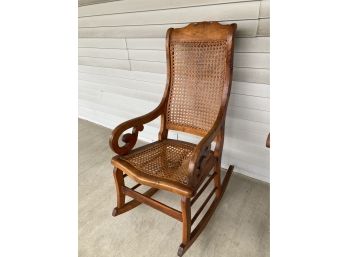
xmin=79 ymin=0 xmax=270 ymax=181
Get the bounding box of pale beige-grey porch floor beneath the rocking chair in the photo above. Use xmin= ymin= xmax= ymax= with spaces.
xmin=79 ymin=120 xmax=269 ymax=257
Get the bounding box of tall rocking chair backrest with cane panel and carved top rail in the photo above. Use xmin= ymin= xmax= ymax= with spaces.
xmin=164 ymin=22 xmax=236 ymax=136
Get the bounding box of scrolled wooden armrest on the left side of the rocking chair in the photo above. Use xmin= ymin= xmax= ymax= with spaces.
xmin=109 ymin=104 xmax=163 ymax=155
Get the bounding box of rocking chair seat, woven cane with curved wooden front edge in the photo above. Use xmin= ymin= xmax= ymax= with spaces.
xmin=112 ymin=139 xmax=213 ymax=195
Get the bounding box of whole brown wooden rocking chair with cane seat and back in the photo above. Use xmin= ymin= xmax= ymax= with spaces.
xmin=110 ymin=22 xmax=237 ymax=256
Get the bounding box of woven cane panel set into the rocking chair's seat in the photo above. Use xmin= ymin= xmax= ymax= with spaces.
xmin=121 ymin=139 xmax=195 ymax=185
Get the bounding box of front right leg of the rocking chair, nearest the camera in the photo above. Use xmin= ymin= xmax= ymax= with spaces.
xmin=178 ymin=197 xmax=191 ymax=256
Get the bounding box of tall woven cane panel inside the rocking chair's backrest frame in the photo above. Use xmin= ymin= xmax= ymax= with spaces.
xmin=167 ymin=40 xmax=227 ymax=133
